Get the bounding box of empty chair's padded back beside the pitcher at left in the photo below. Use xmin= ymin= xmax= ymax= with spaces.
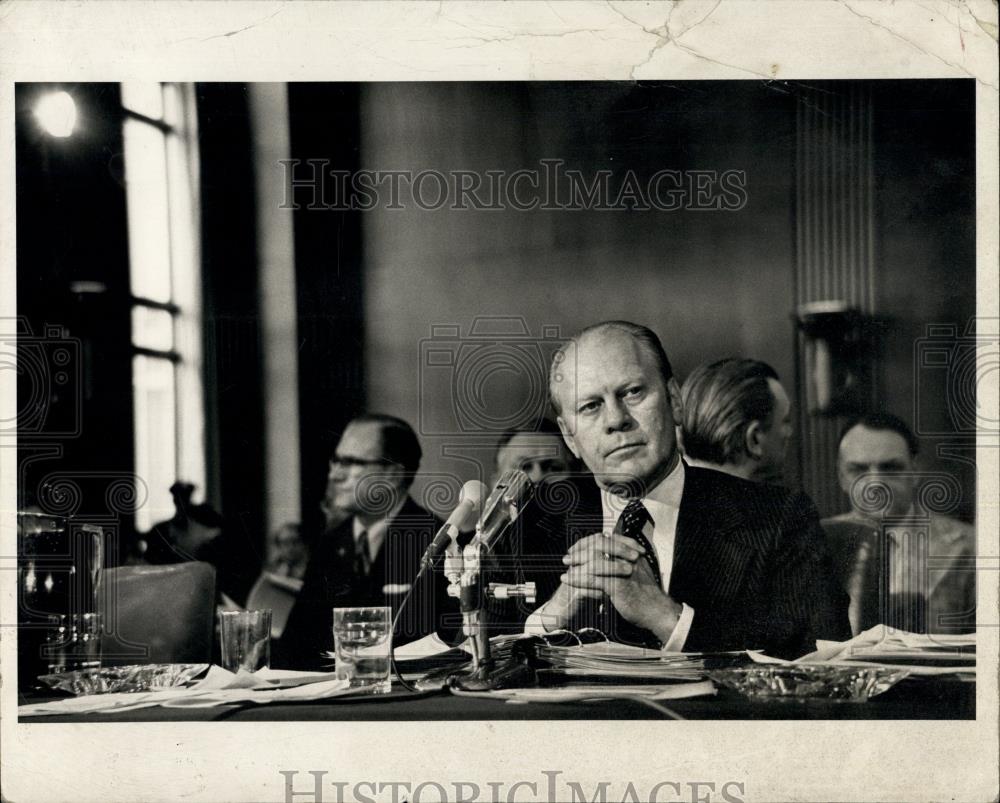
xmin=97 ymin=561 xmax=215 ymax=666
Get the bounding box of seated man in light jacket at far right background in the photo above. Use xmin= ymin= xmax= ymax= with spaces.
xmin=823 ymin=413 xmax=976 ymax=633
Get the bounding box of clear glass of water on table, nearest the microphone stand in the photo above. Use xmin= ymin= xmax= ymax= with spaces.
xmin=333 ymin=607 xmax=392 ymax=694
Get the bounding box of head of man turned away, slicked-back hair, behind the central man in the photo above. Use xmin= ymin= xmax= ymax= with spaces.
xmin=681 ymin=357 xmax=792 ymax=483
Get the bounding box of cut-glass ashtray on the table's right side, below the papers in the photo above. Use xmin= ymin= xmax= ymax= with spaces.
xmin=708 ymin=664 xmax=910 ymax=703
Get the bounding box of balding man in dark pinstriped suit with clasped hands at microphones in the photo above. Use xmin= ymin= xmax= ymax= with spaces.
xmin=526 ymin=321 xmax=850 ymax=658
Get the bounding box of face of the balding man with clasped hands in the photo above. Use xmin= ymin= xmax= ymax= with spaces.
xmin=553 ymin=329 xmax=681 ymax=490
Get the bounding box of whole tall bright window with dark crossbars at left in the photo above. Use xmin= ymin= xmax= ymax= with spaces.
xmin=121 ymin=81 xmax=205 ymax=531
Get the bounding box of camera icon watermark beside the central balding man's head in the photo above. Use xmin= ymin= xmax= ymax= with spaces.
xmin=418 ymin=316 xmax=566 ymax=435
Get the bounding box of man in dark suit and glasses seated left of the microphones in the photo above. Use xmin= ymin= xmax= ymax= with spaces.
xmin=279 ymin=415 xmax=458 ymax=669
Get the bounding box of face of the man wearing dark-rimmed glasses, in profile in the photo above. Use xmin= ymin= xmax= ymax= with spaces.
xmin=327 ymin=421 xmax=402 ymax=513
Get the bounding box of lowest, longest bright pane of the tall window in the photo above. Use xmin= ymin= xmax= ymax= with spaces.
xmin=132 ymin=355 xmax=177 ymax=532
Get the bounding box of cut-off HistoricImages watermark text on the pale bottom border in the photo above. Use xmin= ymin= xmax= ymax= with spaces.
xmin=279 ymin=770 xmax=746 ymax=803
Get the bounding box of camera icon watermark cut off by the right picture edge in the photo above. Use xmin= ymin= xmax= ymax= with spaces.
xmin=913 ymin=318 xmax=1000 ymax=437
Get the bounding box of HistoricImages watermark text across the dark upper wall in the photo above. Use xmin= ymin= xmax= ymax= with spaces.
xmin=279 ymin=159 xmax=747 ymax=212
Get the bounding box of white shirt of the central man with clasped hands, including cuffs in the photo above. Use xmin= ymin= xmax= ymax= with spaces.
xmin=524 ymin=460 xmax=694 ymax=652
